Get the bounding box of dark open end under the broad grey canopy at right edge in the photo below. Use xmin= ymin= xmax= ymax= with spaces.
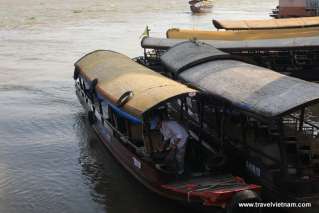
xmin=282 ymin=105 xmax=319 ymax=176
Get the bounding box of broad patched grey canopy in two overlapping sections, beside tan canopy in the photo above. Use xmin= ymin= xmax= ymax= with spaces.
xmin=161 ymin=42 xmax=319 ymax=118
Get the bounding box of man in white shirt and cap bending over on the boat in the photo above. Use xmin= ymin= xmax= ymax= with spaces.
xmin=151 ymin=116 xmax=188 ymax=175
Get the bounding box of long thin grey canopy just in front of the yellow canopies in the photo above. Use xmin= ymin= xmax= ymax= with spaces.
xmin=141 ymin=36 xmax=319 ymax=51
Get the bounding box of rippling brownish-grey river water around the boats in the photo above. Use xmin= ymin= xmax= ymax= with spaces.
xmin=0 ymin=0 xmax=278 ymax=213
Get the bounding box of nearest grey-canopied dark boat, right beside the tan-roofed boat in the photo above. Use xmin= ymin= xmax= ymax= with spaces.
xmin=140 ymin=41 xmax=319 ymax=212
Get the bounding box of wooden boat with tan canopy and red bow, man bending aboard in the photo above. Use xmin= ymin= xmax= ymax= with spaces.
xmin=74 ymin=50 xmax=260 ymax=212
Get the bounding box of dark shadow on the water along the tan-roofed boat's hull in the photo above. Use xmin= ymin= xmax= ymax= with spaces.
xmin=77 ymin=114 xmax=199 ymax=213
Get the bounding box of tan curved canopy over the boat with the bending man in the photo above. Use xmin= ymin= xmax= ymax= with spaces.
xmin=75 ymin=50 xmax=196 ymax=118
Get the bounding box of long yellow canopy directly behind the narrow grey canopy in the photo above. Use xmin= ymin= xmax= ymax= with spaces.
xmin=166 ymin=27 xmax=319 ymax=41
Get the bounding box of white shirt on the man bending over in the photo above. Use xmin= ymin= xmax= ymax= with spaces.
xmin=160 ymin=121 xmax=188 ymax=148
